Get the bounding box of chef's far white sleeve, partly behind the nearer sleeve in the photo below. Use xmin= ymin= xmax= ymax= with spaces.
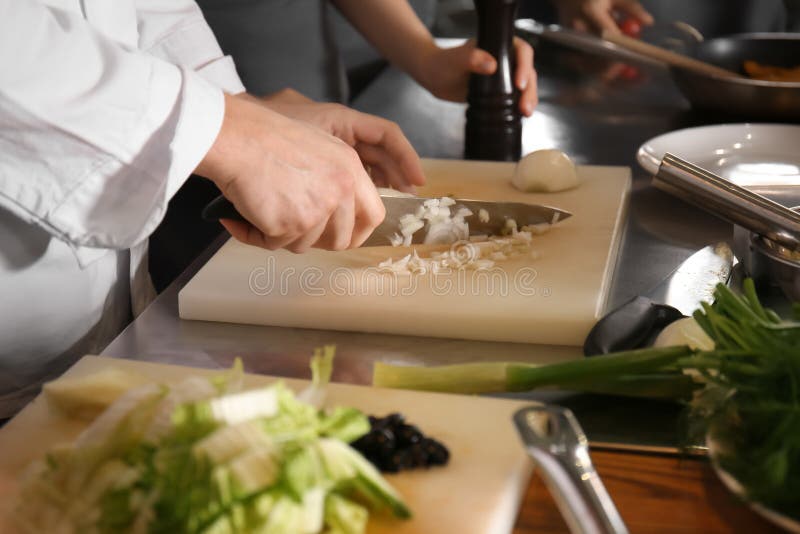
xmin=136 ymin=0 xmax=245 ymax=94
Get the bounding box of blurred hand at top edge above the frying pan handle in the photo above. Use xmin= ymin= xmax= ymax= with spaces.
xmin=556 ymin=0 xmax=653 ymax=34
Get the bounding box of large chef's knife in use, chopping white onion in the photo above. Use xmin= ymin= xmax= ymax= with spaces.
xmin=203 ymin=195 xmax=572 ymax=247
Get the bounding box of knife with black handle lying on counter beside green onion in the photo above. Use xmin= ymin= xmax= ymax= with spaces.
xmin=583 ymin=243 xmax=734 ymax=356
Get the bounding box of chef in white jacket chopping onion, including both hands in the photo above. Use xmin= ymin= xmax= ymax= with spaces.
xmin=0 ymin=0 xmax=424 ymax=419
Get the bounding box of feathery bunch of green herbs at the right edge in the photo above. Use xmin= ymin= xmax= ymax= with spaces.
xmin=682 ymin=280 xmax=800 ymax=519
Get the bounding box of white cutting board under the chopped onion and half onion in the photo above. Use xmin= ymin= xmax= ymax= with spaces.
xmin=179 ymin=160 xmax=630 ymax=346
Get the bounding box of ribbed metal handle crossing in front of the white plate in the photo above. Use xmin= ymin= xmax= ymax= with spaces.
xmin=653 ymin=153 xmax=800 ymax=250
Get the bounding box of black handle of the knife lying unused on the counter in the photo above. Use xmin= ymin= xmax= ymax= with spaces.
xmin=583 ymin=297 xmax=684 ymax=356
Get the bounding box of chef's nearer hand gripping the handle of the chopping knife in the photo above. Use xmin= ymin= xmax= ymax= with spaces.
xmin=195 ymin=95 xmax=385 ymax=252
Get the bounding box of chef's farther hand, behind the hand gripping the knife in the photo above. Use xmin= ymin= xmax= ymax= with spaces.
xmin=253 ymin=89 xmax=425 ymax=193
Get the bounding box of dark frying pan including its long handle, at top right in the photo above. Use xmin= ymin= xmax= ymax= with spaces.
xmin=516 ymin=19 xmax=800 ymax=121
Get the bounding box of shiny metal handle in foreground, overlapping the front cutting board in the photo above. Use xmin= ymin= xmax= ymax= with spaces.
xmin=514 ymin=406 xmax=628 ymax=534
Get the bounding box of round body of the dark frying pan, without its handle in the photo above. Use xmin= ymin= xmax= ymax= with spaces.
xmin=670 ymin=33 xmax=800 ymax=120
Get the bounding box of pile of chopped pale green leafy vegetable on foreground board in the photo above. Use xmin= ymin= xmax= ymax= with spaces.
xmin=14 ymin=353 xmax=410 ymax=534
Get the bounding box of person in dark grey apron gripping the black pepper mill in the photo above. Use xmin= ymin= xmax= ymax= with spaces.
xmin=198 ymin=0 xmax=536 ymax=115
